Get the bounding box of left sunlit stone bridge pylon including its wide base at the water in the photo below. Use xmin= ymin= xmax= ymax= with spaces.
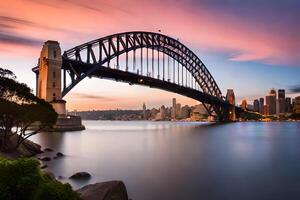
xmin=34 ymin=41 xmax=84 ymax=131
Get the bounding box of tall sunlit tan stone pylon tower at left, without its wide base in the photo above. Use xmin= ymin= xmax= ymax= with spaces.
xmin=37 ymin=40 xmax=66 ymax=115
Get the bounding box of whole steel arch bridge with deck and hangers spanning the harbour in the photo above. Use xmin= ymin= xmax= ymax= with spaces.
xmin=33 ymin=31 xmax=243 ymax=121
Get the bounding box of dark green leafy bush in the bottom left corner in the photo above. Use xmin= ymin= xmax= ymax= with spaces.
xmin=0 ymin=158 xmax=80 ymax=200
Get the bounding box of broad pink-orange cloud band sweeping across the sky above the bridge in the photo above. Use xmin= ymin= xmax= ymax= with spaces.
xmin=0 ymin=0 xmax=300 ymax=65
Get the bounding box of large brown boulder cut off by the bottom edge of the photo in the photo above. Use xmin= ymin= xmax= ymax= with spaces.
xmin=77 ymin=181 xmax=128 ymax=200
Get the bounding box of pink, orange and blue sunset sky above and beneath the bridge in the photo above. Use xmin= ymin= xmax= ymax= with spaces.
xmin=0 ymin=0 xmax=300 ymax=110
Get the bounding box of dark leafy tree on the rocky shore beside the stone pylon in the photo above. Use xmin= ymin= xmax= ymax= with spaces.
xmin=0 ymin=68 xmax=57 ymax=151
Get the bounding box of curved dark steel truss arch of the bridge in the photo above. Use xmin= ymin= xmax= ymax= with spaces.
xmin=62 ymin=32 xmax=226 ymax=115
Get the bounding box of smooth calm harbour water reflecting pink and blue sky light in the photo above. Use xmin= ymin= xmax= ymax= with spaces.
xmin=33 ymin=121 xmax=300 ymax=200
